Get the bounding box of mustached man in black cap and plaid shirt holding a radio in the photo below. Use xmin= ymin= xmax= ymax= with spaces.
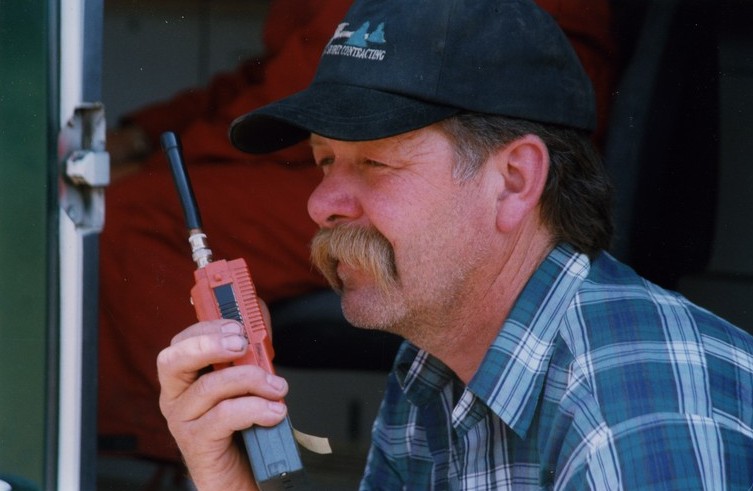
xmin=158 ymin=0 xmax=753 ymax=490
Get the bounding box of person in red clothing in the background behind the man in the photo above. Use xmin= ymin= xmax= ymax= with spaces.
xmin=98 ymin=0 xmax=616 ymax=462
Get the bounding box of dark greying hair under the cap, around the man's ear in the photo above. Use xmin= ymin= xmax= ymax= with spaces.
xmin=440 ymin=113 xmax=614 ymax=258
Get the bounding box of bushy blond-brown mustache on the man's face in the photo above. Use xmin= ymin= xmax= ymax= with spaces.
xmin=311 ymin=225 xmax=399 ymax=292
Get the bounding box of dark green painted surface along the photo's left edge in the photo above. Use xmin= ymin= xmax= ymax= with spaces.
xmin=0 ymin=0 xmax=50 ymax=489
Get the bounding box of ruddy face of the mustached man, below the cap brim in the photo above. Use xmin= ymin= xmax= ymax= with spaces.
xmin=308 ymin=126 xmax=497 ymax=338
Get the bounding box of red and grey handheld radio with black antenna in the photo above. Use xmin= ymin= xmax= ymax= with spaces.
xmin=161 ymin=132 xmax=310 ymax=491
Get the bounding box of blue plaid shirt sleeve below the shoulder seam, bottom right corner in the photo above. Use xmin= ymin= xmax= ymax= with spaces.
xmin=555 ymin=413 xmax=753 ymax=490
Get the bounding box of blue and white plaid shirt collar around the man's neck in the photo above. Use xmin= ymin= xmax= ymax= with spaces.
xmin=394 ymin=245 xmax=590 ymax=438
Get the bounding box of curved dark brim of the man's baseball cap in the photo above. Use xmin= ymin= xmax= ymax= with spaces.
xmin=230 ymin=83 xmax=460 ymax=154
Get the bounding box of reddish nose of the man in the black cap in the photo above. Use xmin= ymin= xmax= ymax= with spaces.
xmin=308 ymin=169 xmax=363 ymax=228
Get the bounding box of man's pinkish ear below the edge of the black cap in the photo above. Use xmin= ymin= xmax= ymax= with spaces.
xmin=492 ymin=135 xmax=549 ymax=232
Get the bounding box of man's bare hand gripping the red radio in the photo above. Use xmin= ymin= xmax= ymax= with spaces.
xmin=157 ymin=320 xmax=288 ymax=491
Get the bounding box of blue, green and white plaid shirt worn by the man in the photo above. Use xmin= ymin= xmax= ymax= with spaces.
xmin=361 ymin=246 xmax=753 ymax=491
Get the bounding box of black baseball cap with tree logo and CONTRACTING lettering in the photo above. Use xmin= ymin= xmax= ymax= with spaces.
xmin=230 ymin=0 xmax=596 ymax=153
